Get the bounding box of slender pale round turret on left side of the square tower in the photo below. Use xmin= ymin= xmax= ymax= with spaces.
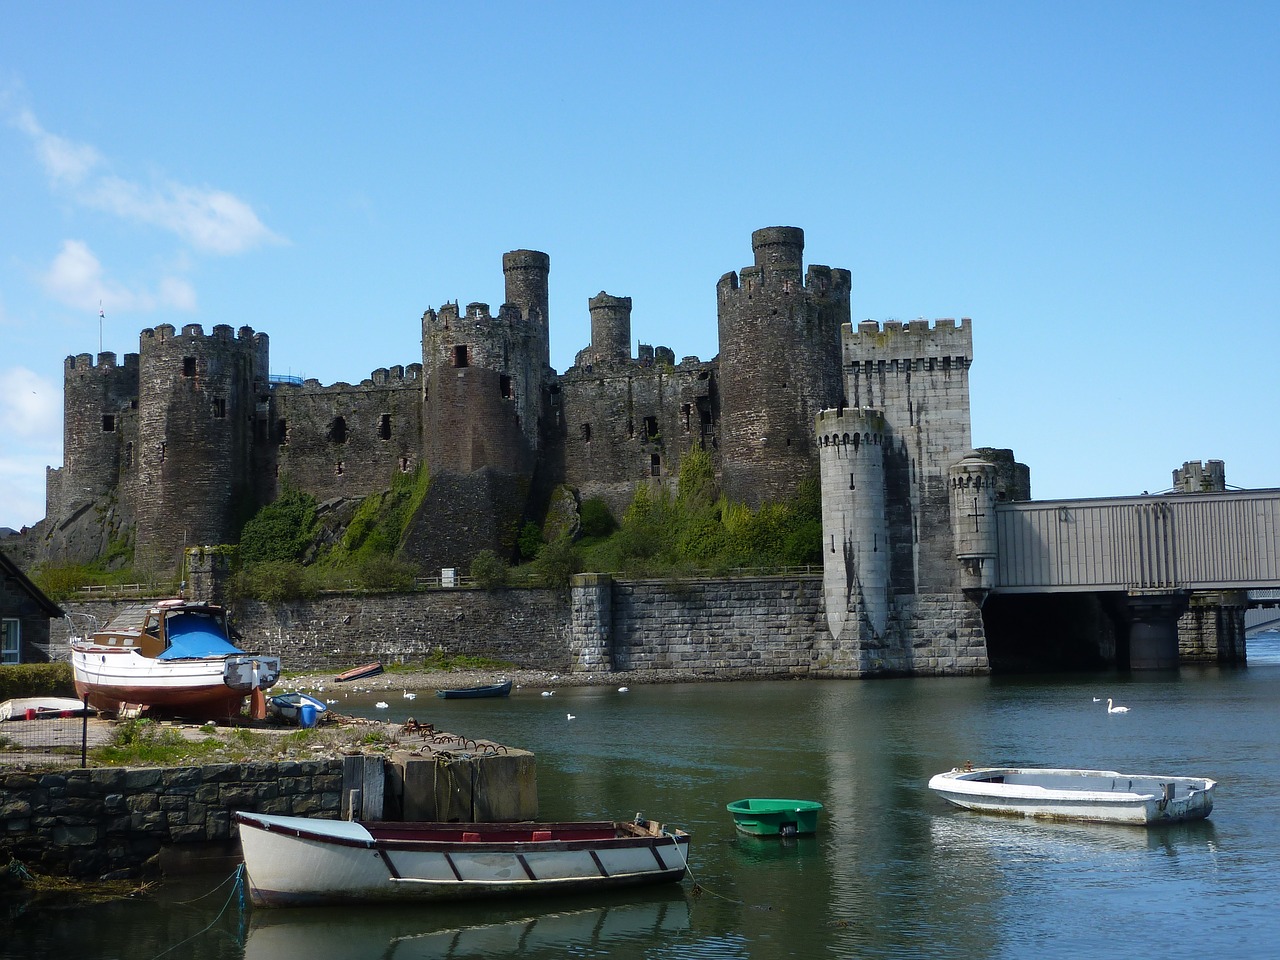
xmin=815 ymin=410 xmax=891 ymax=640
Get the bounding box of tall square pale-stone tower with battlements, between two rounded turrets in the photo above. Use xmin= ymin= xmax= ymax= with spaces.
xmin=844 ymin=319 xmax=973 ymax=594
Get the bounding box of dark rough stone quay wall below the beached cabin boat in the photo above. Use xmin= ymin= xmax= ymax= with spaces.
xmin=0 ymin=758 xmax=343 ymax=878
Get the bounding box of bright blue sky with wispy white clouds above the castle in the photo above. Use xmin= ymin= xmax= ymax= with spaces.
xmin=0 ymin=0 xmax=1280 ymax=527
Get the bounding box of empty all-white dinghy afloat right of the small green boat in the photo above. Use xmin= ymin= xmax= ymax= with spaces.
xmin=929 ymin=768 xmax=1217 ymax=826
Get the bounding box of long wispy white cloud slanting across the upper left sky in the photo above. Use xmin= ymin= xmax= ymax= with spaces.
xmin=14 ymin=110 xmax=283 ymax=255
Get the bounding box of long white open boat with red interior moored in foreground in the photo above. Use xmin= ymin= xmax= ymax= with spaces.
xmin=234 ymin=813 xmax=689 ymax=906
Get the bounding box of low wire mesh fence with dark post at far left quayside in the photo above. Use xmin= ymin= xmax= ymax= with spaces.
xmin=0 ymin=698 xmax=99 ymax=767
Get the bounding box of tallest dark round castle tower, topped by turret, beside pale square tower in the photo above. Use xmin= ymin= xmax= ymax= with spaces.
xmin=717 ymin=227 xmax=851 ymax=506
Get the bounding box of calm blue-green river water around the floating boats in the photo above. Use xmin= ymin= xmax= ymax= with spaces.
xmin=0 ymin=635 xmax=1280 ymax=960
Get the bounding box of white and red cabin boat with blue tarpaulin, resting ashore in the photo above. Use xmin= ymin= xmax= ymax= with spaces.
xmin=72 ymin=599 xmax=280 ymax=719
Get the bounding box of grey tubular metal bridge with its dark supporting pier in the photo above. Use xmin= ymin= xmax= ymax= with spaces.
xmin=975 ymin=489 xmax=1280 ymax=667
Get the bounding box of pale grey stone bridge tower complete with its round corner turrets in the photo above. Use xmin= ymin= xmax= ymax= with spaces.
xmin=814 ymin=320 xmax=1000 ymax=675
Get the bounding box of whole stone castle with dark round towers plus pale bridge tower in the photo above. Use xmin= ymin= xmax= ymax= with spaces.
xmin=12 ymin=227 xmax=1249 ymax=675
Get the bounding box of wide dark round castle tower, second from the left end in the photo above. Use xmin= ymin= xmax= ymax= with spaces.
xmin=134 ymin=324 xmax=268 ymax=568
